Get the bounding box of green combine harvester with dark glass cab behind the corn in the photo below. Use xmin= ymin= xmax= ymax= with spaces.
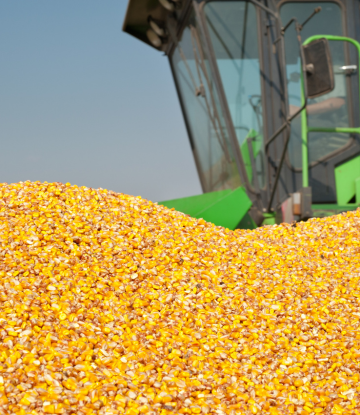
xmin=124 ymin=0 xmax=360 ymax=229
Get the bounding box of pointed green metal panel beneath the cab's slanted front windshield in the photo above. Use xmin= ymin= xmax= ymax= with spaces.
xmin=159 ymin=187 xmax=252 ymax=229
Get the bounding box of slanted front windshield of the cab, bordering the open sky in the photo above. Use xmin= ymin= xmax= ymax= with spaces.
xmin=171 ymin=14 xmax=241 ymax=192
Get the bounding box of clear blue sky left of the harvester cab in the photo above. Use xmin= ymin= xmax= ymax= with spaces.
xmin=0 ymin=0 xmax=201 ymax=201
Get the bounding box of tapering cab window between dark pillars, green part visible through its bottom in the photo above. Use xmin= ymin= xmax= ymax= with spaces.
xmin=204 ymin=0 xmax=265 ymax=188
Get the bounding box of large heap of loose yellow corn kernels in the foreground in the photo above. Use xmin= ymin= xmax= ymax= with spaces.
xmin=0 ymin=182 xmax=360 ymax=415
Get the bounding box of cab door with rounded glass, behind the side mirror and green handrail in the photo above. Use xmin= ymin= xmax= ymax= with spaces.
xmin=279 ymin=1 xmax=360 ymax=204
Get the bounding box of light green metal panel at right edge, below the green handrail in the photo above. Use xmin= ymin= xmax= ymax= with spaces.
xmin=335 ymin=156 xmax=360 ymax=205
